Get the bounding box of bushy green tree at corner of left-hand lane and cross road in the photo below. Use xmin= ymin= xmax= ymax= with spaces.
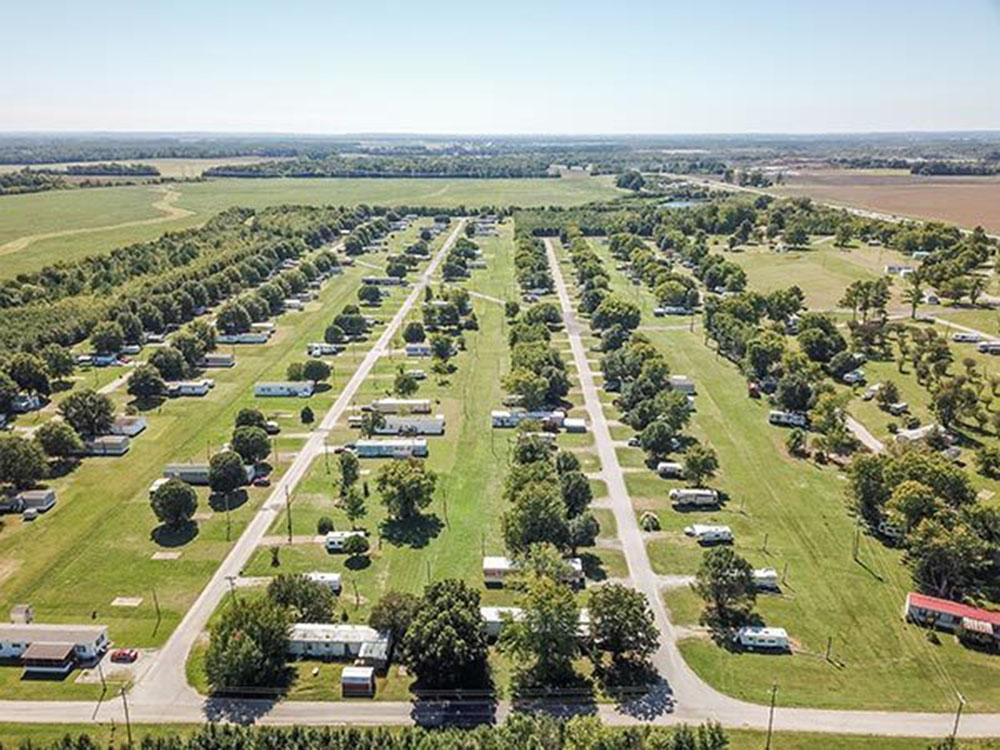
xmin=205 ymin=597 xmax=289 ymax=692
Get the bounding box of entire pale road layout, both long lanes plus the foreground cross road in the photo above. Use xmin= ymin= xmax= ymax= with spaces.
xmin=0 ymin=226 xmax=1000 ymax=737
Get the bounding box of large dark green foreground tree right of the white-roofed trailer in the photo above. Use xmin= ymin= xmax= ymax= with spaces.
xmin=402 ymin=579 xmax=487 ymax=688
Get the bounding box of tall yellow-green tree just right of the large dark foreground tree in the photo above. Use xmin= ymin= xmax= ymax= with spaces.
xmin=500 ymin=576 xmax=580 ymax=686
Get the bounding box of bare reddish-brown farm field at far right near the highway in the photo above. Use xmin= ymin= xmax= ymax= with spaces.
xmin=768 ymin=169 xmax=1000 ymax=233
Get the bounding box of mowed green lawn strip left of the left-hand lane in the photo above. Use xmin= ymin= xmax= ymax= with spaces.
xmin=0 ymin=223 xmax=443 ymax=704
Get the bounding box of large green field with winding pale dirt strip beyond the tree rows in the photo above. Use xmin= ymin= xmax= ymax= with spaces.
xmin=0 ymin=177 xmax=620 ymax=279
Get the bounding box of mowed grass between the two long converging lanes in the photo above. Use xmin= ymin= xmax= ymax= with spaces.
xmin=188 ymin=222 xmax=627 ymax=700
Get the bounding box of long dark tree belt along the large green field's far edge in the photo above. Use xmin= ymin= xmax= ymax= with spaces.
xmin=204 ymin=155 xmax=558 ymax=178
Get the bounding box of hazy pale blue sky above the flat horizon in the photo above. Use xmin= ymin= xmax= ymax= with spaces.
xmin=0 ymin=0 xmax=1000 ymax=133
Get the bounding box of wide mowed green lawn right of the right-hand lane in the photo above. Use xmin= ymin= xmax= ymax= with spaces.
xmin=580 ymin=243 xmax=1000 ymax=711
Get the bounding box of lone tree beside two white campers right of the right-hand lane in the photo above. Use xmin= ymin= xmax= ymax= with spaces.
xmin=692 ymin=547 xmax=757 ymax=626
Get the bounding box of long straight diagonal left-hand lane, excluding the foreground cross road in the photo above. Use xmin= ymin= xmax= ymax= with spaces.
xmin=127 ymin=221 xmax=464 ymax=705
